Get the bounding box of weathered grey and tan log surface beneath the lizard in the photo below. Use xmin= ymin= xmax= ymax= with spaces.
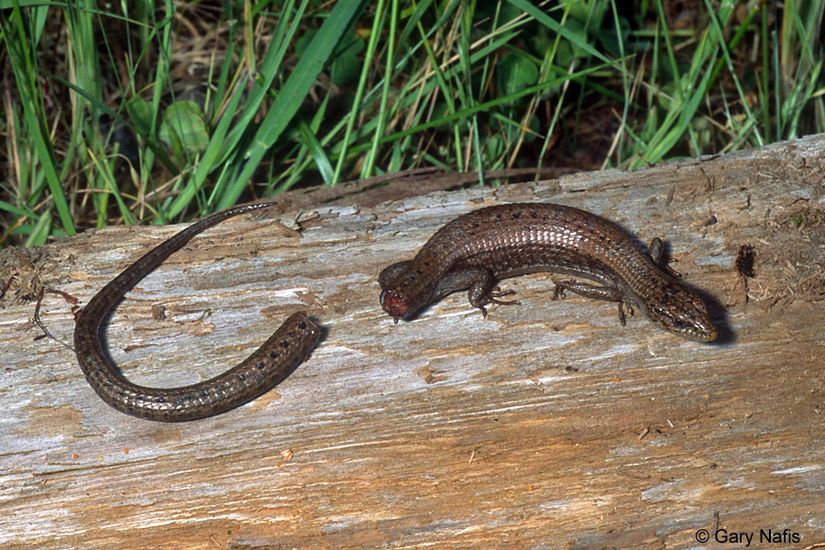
xmin=0 ymin=136 xmax=825 ymax=548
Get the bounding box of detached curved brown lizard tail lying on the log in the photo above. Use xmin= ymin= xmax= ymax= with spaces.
xmin=74 ymin=203 xmax=321 ymax=422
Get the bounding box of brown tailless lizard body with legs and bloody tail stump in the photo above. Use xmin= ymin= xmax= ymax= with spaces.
xmin=378 ymin=203 xmax=717 ymax=341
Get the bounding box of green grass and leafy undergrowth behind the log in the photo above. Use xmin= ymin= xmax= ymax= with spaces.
xmin=0 ymin=0 xmax=825 ymax=246
